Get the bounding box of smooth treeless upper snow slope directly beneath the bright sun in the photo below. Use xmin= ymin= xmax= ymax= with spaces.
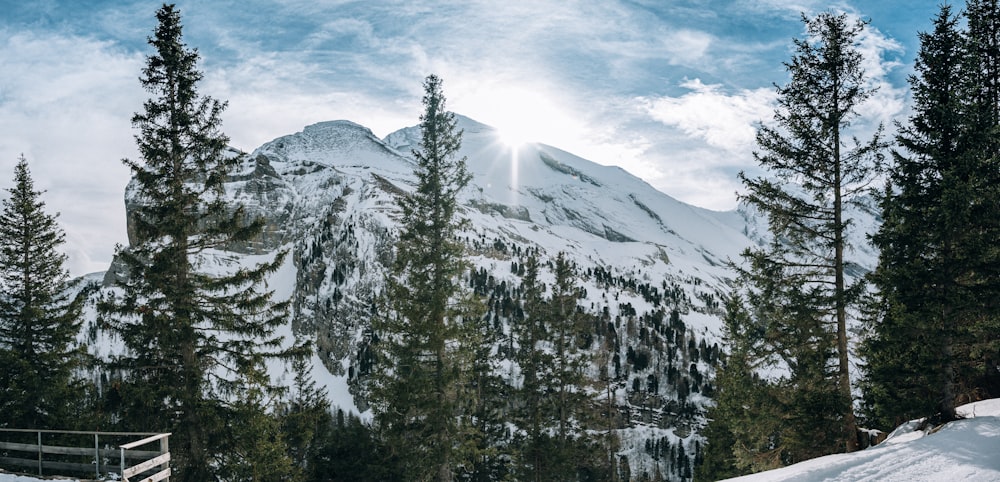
xmin=386 ymin=116 xmax=749 ymax=277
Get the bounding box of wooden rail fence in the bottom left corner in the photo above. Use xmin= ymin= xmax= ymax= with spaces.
xmin=0 ymin=429 xmax=170 ymax=482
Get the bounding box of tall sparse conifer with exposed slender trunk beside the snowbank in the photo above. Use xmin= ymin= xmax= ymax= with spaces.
xmin=740 ymin=13 xmax=885 ymax=451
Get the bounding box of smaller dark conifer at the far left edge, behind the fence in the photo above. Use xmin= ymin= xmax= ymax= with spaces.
xmin=0 ymin=156 xmax=83 ymax=429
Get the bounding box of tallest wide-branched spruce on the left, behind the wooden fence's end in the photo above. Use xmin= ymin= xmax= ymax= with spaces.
xmin=99 ymin=5 xmax=302 ymax=481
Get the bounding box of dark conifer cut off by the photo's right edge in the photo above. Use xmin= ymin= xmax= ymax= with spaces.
xmin=942 ymin=0 xmax=1000 ymax=401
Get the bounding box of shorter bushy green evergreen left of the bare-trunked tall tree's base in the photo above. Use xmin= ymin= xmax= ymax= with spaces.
xmin=700 ymin=274 xmax=843 ymax=478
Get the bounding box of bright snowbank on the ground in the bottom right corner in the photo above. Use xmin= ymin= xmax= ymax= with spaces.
xmin=729 ymin=399 xmax=1000 ymax=482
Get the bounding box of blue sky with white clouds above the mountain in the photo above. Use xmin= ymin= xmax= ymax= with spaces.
xmin=0 ymin=0 xmax=948 ymax=274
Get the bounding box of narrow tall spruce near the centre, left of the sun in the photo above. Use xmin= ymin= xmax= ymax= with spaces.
xmin=372 ymin=75 xmax=482 ymax=481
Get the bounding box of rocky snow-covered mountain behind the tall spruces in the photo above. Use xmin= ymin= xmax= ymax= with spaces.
xmin=94 ymin=116 xmax=875 ymax=478
